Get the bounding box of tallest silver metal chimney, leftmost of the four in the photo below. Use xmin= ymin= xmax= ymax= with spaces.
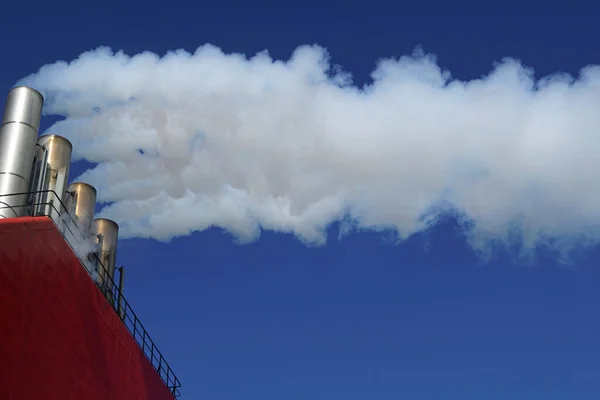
xmin=0 ymin=86 xmax=44 ymax=218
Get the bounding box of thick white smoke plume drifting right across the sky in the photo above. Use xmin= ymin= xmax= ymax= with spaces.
xmin=14 ymin=45 xmax=600 ymax=256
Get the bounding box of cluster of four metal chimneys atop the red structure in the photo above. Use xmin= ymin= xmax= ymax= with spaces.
xmin=0 ymin=86 xmax=119 ymax=284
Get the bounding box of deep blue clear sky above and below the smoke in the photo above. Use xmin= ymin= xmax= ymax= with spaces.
xmin=0 ymin=0 xmax=600 ymax=400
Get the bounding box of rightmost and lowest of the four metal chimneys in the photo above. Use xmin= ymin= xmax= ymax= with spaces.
xmin=92 ymin=218 xmax=119 ymax=290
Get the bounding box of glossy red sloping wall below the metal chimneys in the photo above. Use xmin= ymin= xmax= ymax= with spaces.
xmin=0 ymin=217 xmax=173 ymax=400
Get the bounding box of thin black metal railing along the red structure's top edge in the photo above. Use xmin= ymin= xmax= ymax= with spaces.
xmin=0 ymin=190 xmax=181 ymax=397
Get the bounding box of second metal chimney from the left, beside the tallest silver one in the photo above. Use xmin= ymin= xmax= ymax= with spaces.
xmin=34 ymin=135 xmax=73 ymax=223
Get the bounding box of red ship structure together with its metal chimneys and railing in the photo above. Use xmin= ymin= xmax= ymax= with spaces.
xmin=0 ymin=86 xmax=180 ymax=400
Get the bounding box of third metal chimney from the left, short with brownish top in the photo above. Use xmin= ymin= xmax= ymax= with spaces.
xmin=65 ymin=182 xmax=97 ymax=237
